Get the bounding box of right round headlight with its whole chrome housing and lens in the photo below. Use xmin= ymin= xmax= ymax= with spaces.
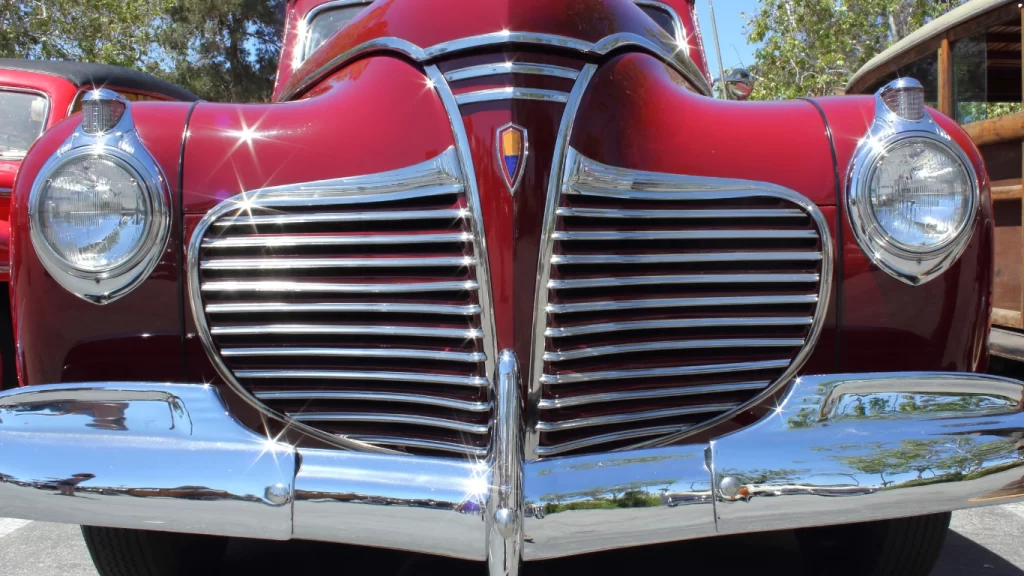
xmin=848 ymin=80 xmax=978 ymax=285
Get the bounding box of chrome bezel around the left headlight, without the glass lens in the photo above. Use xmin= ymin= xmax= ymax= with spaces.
xmin=29 ymin=89 xmax=171 ymax=304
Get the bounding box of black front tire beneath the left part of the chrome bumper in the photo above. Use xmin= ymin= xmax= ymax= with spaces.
xmin=82 ymin=526 xmax=227 ymax=576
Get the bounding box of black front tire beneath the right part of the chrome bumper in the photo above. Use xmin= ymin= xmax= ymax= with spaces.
xmin=796 ymin=512 xmax=951 ymax=576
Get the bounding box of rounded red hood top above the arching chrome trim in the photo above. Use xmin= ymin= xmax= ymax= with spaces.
xmin=274 ymin=0 xmax=668 ymax=99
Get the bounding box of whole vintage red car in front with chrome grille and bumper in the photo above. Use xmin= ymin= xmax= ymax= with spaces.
xmin=0 ymin=0 xmax=1024 ymax=574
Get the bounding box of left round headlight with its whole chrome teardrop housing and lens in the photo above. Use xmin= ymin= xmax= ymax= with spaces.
xmin=29 ymin=88 xmax=171 ymax=304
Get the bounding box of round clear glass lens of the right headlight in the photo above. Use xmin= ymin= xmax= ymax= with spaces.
xmin=867 ymin=138 xmax=974 ymax=252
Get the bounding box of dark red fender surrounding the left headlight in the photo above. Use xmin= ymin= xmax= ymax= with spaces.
xmin=11 ymin=102 xmax=191 ymax=385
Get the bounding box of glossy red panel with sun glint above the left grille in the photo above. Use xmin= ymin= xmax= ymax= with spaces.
xmin=183 ymin=56 xmax=454 ymax=213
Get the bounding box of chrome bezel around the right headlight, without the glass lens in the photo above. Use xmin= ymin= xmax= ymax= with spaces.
xmin=846 ymin=79 xmax=980 ymax=286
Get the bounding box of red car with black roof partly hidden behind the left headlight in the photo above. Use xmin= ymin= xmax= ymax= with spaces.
xmin=0 ymin=58 xmax=198 ymax=388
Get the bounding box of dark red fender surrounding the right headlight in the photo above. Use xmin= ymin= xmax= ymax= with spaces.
xmin=817 ymin=96 xmax=993 ymax=372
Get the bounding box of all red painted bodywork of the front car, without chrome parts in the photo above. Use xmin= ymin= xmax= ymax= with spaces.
xmin=12 ymin=0 xmax=992 ymax=448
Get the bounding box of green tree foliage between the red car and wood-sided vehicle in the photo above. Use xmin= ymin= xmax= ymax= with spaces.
xmin=744 ymin=0 xmax=963 ymax=99
